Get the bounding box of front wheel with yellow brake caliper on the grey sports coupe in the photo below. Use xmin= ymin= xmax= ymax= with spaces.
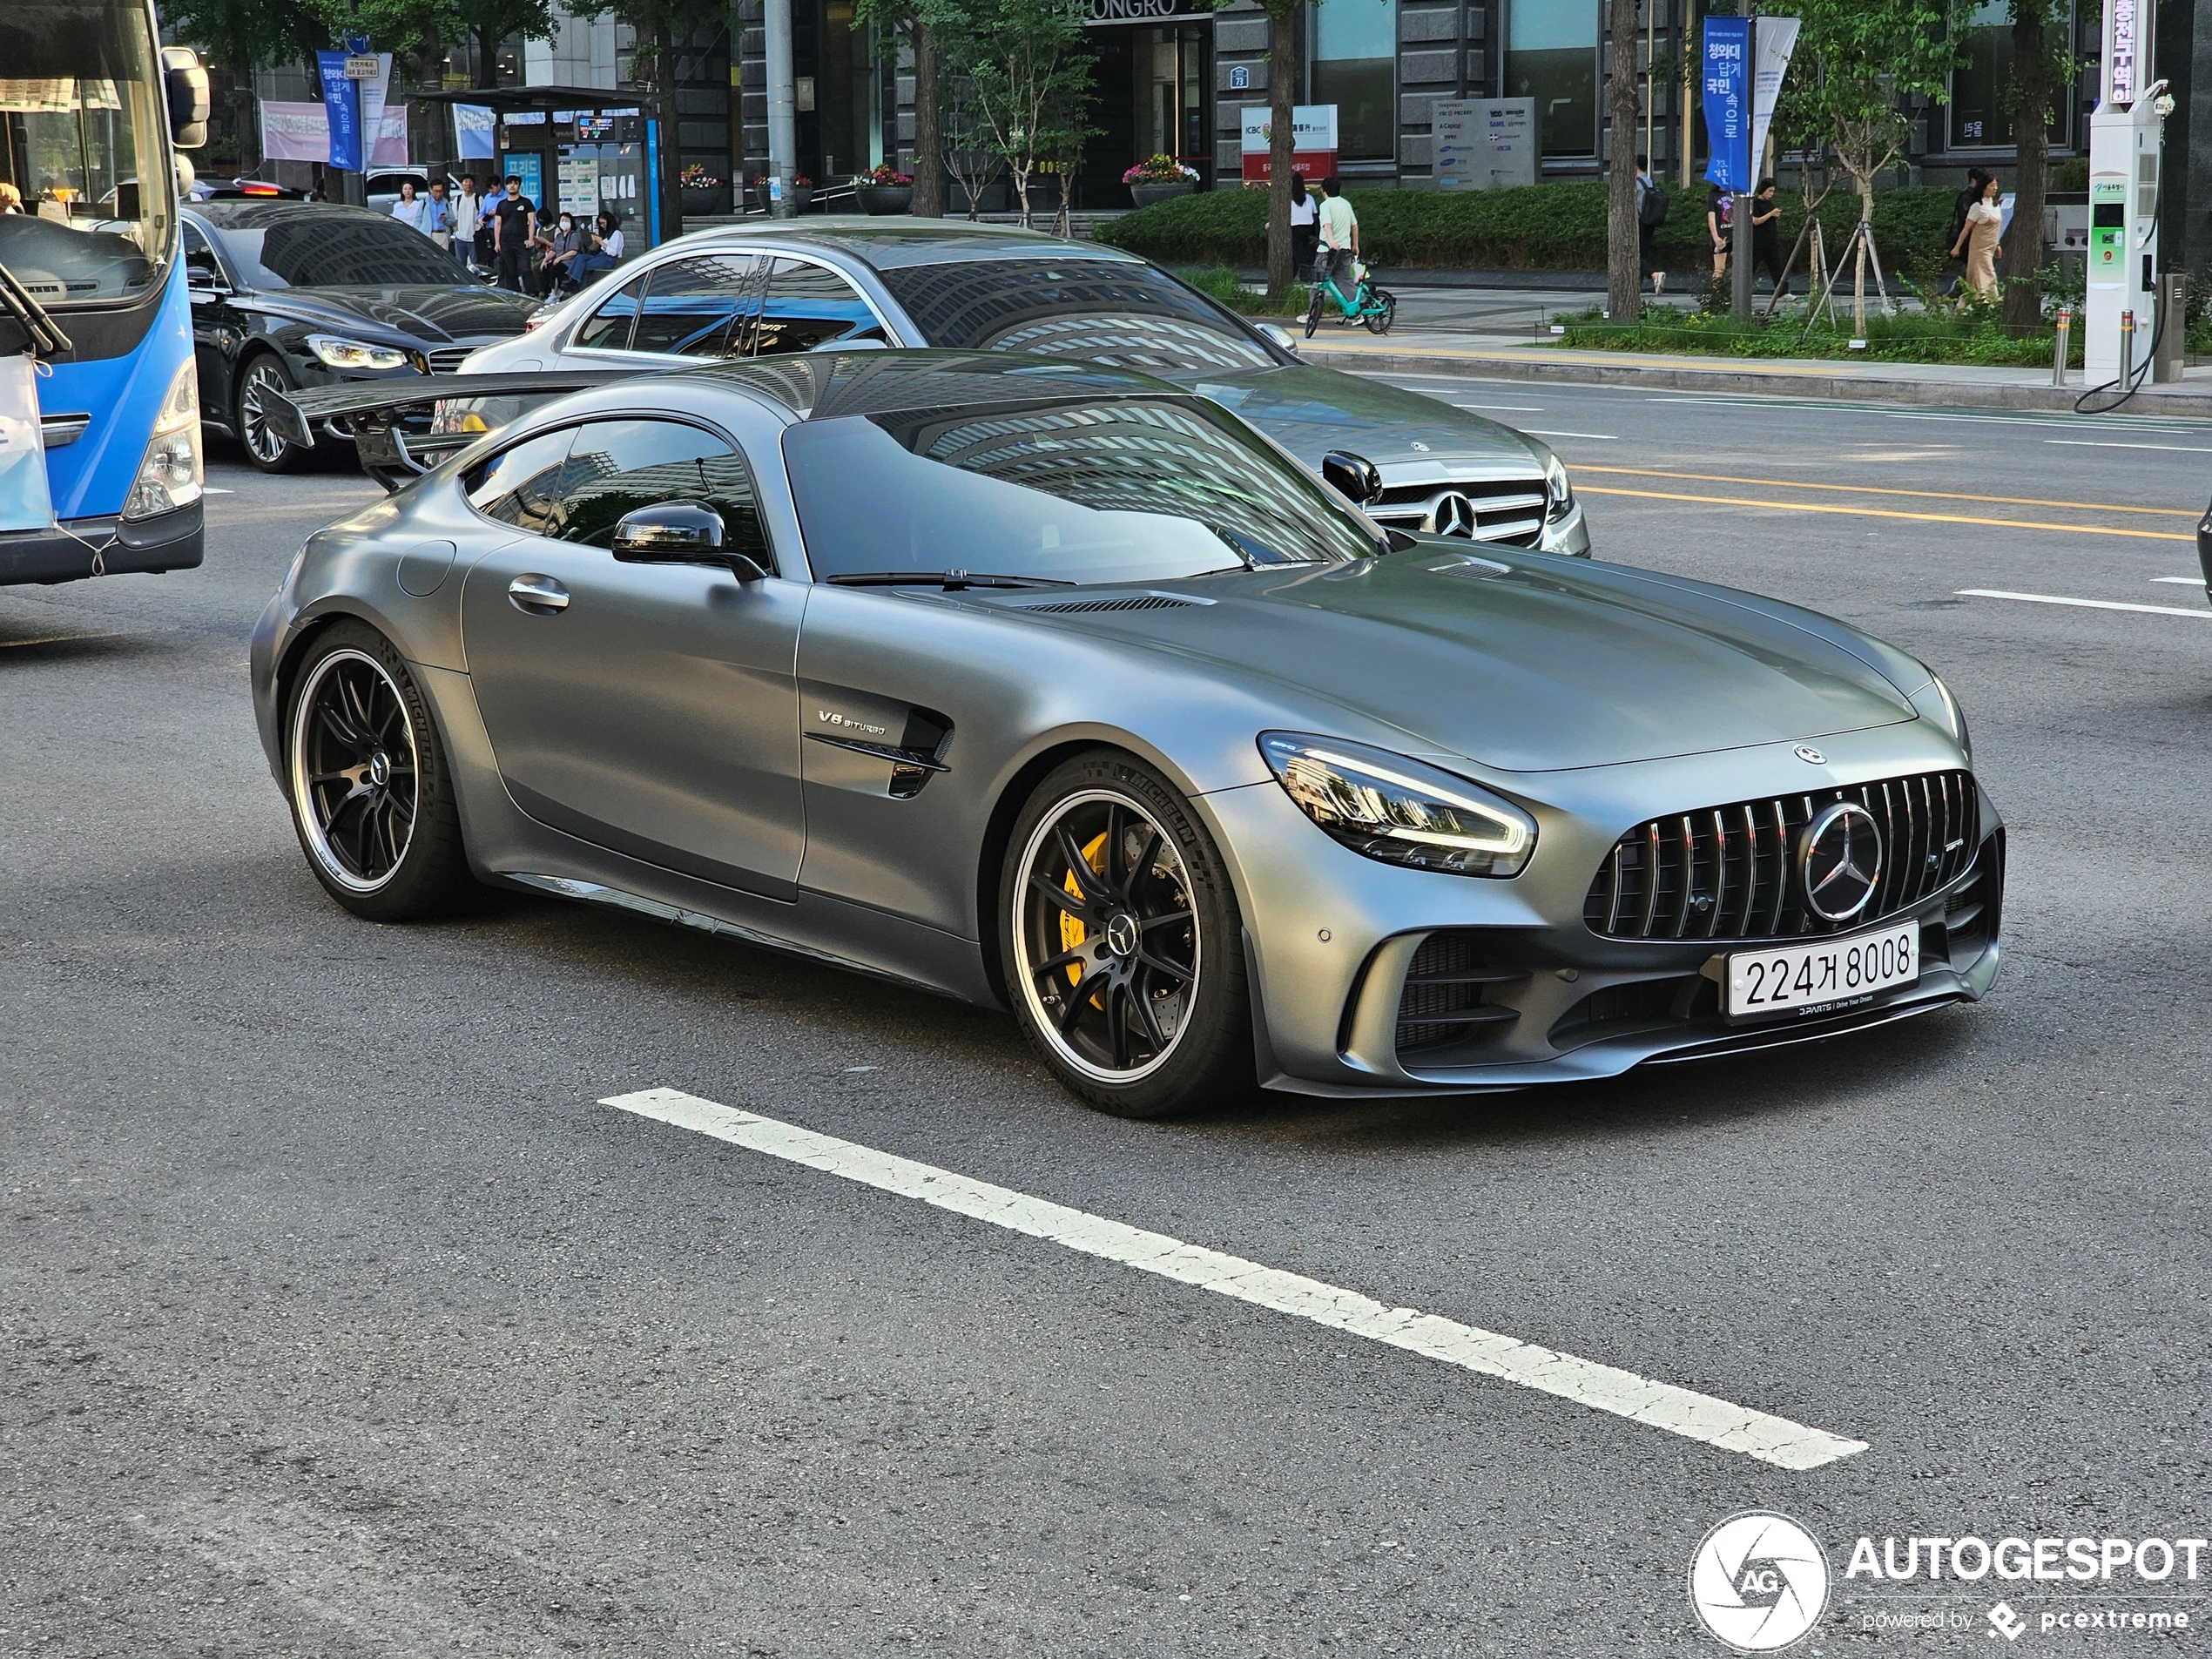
xmin=1000 ymin=752 xmax=1254 ymax=1117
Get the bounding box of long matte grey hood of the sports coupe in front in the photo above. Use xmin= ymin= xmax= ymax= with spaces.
xmin=1002 ymin=553 xmax=1926 ymax=772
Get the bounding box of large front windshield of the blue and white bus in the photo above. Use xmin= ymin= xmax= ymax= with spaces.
xmin=0 ymin=0 xmax=177 ymax=306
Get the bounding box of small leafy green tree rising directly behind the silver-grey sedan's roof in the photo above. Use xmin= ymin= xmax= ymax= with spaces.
xmin=955 ymin=0 xmax=1097 ymax=228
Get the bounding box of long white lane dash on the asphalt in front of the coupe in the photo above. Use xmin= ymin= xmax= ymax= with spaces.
xmin=599 ymin=1089 xmax=1867 ymax=1469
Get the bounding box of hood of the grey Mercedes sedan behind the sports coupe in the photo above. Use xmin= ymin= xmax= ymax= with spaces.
xmin=1155 ymin=363 xmax=1546 ymax=482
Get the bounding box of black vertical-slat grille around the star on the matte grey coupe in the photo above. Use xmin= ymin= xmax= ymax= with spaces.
xmin=1581 ymin=772 xmax=1982 ymax=941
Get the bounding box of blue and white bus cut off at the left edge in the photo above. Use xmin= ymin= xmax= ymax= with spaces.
xmin=0 ymin=0 xmax=208 ymax=584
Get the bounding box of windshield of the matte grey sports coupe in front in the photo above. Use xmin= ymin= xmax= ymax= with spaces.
xmin=783 ymin=398 xmax=1376 ymax=584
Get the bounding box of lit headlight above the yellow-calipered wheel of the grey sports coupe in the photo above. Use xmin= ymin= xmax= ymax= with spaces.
xmin=1258 ymin=732 xmax=1535 ymax=876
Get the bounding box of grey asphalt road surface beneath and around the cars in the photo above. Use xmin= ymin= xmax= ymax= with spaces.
xmin=0 ymin=400 xmax=2212 ymax=1659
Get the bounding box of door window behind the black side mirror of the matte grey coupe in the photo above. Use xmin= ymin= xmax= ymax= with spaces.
xmin=560 ymin=421 xmax=777 ymax=570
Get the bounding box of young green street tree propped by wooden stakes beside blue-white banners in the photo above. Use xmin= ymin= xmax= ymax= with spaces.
xmin=1777 ymin=0 xmax=1971 ymax=332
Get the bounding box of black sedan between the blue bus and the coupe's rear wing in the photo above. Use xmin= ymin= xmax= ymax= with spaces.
xmin=184 ymin=199 xmax=537 ymax=471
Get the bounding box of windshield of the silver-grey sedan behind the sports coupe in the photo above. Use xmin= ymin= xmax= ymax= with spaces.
xmin=882 ymin=259 xmax=1274 ymax=374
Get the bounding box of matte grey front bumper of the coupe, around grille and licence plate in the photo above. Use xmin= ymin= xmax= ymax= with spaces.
xmin=1204 ymin=721 xmax=2004 ymax=1097
